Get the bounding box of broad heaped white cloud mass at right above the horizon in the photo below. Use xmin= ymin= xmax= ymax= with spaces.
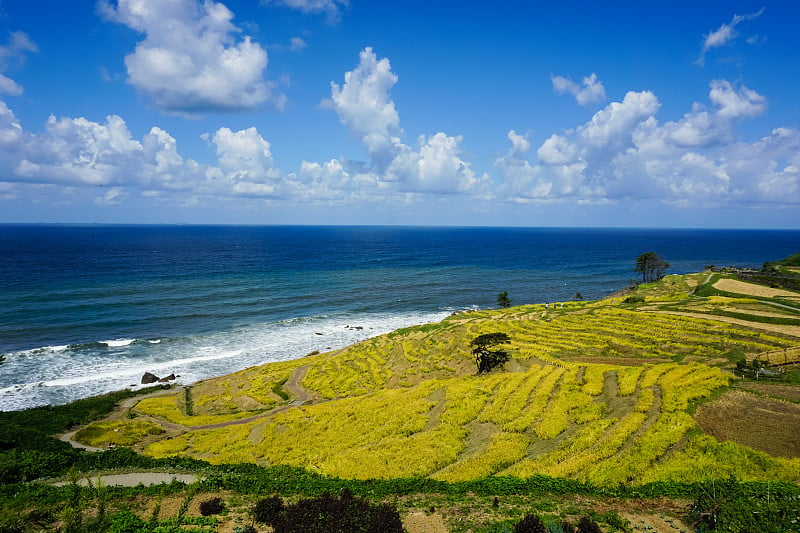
xmin=495 ymin=80 xmax=800 ymax=206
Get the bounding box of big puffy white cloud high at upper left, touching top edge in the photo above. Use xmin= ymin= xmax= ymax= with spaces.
xmin=100 ymin=0 xmax=285 ymax=115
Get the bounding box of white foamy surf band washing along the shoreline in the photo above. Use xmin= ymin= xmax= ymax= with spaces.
xmin=0 ymin=311 xmax=450 ymax=411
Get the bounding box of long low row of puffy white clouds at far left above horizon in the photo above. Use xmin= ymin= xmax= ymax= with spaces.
xmin=0 ymin=94 xmax=300 ymax=205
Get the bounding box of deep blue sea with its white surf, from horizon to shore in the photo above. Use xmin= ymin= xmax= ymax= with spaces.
xmin=0 ymin=225 xmax=800 ymax=410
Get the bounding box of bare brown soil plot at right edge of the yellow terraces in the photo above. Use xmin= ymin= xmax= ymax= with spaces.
xmin=695 ymin=390 xmax=800 ymax=457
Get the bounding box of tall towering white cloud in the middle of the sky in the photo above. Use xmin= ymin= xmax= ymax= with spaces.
xmin=324 ymin=47 xmax=487 ymax=194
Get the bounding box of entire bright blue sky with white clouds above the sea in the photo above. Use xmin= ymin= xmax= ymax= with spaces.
xmin=0 ymin=0 xmax=800 ymax=228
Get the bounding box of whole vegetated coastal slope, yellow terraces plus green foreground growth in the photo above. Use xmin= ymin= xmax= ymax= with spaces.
xmin=0 ymin=266 xmax=800 ymax=533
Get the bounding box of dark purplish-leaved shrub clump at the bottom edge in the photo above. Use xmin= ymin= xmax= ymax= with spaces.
xmin=253 ymin=489 xmax=403 ymax=533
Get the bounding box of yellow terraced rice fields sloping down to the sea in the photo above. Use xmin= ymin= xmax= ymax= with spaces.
xmin=77 ymin=272 xmax=800 ymax=486
